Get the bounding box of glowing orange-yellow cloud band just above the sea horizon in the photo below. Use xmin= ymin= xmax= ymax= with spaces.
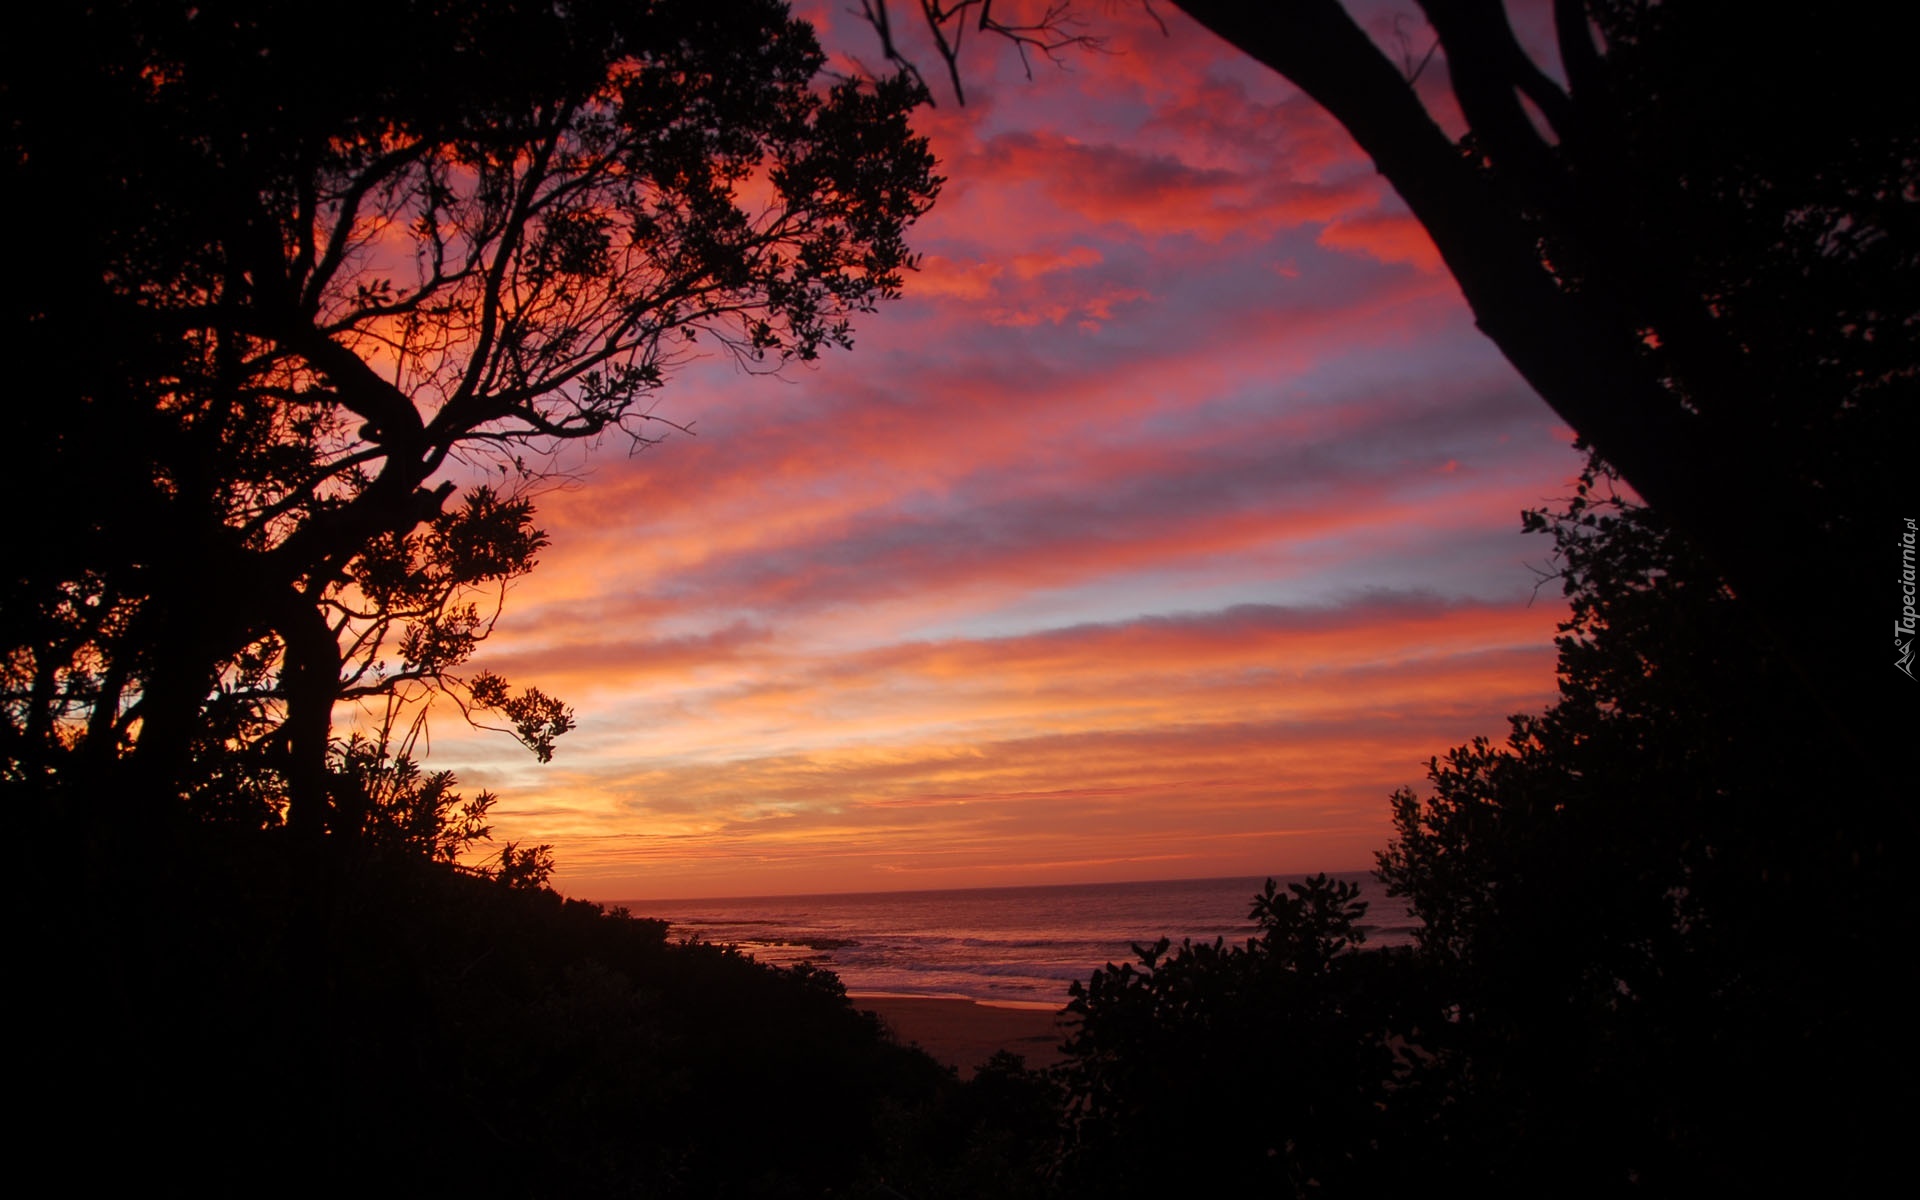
xmin=439 ymin=595 xmax=1553 ymax=897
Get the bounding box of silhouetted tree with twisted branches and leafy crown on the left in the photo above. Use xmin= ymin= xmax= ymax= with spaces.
xmin=0 ymin=0 xmax=939 ymax=833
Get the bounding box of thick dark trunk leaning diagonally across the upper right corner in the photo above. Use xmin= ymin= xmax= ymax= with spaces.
xmin=1177 ymin=0 xmax=1914 ymax=787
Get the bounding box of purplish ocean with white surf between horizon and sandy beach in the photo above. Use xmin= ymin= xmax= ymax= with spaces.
xmin=626 ymin=872 xmax=1417 ymax=1010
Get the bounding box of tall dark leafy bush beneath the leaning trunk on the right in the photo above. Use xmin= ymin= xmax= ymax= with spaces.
xmin=1379 ymin=456 xmax=1914 ymax=1194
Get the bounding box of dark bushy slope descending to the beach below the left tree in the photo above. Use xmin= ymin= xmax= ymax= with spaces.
xmin=30 ymin=837 xmax=991 ymax=1198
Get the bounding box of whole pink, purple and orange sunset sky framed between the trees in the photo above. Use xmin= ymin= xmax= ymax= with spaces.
xmin=397 ymin=4 xmax=1578 ymax=900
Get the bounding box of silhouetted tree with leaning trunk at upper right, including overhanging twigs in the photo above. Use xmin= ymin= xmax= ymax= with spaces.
xmin=864 ymin=0 xmax=1920 ymax=768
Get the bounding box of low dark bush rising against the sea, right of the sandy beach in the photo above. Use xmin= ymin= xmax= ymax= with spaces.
xmin=1058 ymin=876 xmax=1415 ymax=1196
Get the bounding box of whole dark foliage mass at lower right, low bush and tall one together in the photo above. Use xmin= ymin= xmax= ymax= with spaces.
xmin=1060 ymin=461 xmax=1914 ymax=1196
